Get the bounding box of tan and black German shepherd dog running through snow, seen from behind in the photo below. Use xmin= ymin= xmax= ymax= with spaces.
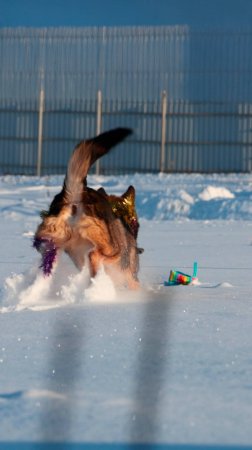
xmin=33 ymin=128 xmax=140 ymax=289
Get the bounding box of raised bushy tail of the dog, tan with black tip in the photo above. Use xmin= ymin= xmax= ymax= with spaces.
xmin=64 ymin=128 xmax=132 ymax=203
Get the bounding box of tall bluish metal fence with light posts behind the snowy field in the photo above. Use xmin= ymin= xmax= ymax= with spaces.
xmin=0 ymin=27 xmax=252 ymax=174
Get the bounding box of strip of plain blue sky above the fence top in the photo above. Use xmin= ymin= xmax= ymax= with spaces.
xmin=0 ymin=0 xmax=252 ymax=28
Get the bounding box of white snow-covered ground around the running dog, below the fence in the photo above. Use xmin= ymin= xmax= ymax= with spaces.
xmin=0 ymin=174 xmax=252 ymax=448
